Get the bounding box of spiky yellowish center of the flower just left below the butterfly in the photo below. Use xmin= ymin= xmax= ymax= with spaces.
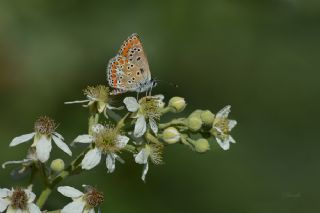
xmin=83 ymin=85 xmax=109 ymax=103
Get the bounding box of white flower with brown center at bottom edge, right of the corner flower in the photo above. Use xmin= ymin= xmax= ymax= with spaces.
xmin=58 ymin=185 xmax=104 ymax=213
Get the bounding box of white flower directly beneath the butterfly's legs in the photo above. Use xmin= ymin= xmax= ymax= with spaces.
xmin=123 ymin=95 xmax=164 ymax=138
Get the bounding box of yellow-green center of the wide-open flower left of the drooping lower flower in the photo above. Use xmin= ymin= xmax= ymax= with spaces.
xmin=95 ymin=127 xmax=120 ymax=153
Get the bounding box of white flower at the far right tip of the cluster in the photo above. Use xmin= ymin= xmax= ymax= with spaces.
xmin=210 ymin=105 xmax=237 ymax=150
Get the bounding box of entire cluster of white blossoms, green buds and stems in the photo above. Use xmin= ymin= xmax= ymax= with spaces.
xmin=0 ymin=85 xmax=237 ymax=213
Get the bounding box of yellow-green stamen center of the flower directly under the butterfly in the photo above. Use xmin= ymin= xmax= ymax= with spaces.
xmin=139 ymin=96 xmax=161 ymax=120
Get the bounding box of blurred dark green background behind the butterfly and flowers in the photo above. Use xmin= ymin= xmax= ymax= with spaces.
xmin=0 ymin=0 xmax=320 ymax=213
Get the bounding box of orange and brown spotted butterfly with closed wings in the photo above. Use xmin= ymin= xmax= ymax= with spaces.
xmin=107 ymin=33 xmax=157 ymax=95
